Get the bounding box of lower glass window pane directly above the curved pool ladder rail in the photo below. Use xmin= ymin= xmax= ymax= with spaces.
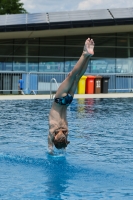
xmin=39 ymin=58 xmax=64 ymax=72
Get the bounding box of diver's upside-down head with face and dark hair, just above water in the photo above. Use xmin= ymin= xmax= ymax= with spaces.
xmin=53 ymin=129 xmax=70 ymax=149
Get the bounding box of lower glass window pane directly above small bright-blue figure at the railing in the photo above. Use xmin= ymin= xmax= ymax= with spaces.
xmin=13 ymin=57 xmax=26 ymax=71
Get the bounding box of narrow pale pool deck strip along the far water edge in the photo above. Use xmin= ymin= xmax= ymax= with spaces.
xmin=0 ymin=93 xmax=133 ymax=100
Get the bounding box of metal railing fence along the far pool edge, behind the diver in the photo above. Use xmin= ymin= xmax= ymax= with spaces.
xmin=0 ymin=71 xmax=133 ymax=94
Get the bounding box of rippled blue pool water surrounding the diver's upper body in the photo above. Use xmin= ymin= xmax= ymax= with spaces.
xmin=0 ymin=98 xmax=133 ymax=200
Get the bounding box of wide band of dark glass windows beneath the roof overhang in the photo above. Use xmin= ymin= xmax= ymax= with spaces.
xmin=0 ymin=33 xmax=133 ymax=73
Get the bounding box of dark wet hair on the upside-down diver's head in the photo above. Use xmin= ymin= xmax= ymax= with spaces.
xmin=53 ymin=136 xmax=70 ymax=149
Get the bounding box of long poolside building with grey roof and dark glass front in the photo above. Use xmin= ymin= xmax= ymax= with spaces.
xmin=0 ymin=8 xmax=133 ymax=91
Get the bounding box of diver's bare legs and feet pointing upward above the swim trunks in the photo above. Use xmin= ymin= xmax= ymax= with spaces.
xmin=55 ymin=38 xmax=94 ymax=98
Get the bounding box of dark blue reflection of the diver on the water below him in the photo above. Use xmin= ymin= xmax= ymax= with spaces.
xmin=44 ymin=157 xmax=71 ymax=199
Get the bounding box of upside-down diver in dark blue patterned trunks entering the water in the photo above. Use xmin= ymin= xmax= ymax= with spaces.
xmin=48 ymin=38 xmax=94 ymax=153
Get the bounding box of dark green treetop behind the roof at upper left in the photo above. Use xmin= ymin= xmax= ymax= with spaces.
xmin=0 ymin=0 xmax=27 ymax=15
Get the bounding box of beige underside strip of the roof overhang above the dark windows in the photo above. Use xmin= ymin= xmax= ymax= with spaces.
xmin=0 ymin=25 xmax=133 ymax=39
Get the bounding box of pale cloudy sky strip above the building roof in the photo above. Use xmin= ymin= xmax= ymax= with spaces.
xmin=20 ymin=0 xmax=133 ymax=13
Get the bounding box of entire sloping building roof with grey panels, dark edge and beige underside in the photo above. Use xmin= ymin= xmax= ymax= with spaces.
xmin=0 ymin=8 xmax=133 ymax=39
